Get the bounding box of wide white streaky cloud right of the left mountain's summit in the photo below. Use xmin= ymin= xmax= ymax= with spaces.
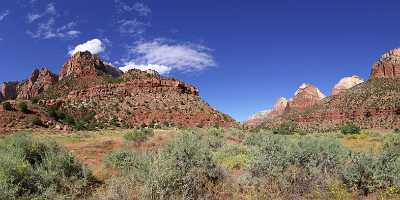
xmin=119 ymin=39 xmax=216 ymax=74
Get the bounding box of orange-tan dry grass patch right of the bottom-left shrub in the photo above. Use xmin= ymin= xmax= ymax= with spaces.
xmin=34 ymin=129 xmax=177 ymax=180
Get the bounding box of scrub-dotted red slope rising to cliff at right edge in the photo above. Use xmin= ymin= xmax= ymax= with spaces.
xmin=268 ymin=49 xmax=400 ymax=131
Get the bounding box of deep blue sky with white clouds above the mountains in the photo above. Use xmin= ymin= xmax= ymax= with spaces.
xmin=0 ymin=0 xmax=400 ymax=120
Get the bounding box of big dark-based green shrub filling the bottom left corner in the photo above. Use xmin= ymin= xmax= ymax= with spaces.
xmin=0 ymin=134 xmax=95 ymax=199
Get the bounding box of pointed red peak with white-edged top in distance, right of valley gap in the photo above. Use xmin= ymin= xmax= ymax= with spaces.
xmin=286 ymin=83 xmax=326 ymax=111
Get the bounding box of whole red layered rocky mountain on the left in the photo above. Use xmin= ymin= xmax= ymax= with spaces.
xmin=0 ymin=52 xmax=236 ymax=128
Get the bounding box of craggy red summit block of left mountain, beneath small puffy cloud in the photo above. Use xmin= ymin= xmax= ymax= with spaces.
xmin=60 ymin=51 xmax=123 ymax=80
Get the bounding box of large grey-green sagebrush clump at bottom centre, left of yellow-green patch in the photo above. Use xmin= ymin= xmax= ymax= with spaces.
xmin=101 ymin=132 xmax=224 ymax=199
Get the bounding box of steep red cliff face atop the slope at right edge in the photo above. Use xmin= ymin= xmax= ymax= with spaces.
xmin=370 ymin=48 xmax=400 ymax=78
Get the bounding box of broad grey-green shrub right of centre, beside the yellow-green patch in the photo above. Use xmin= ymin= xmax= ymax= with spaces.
xmin=248 ymin=134 xmax=348 ymax=199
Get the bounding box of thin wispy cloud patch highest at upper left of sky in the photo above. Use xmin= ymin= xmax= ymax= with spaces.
xmin=27 ymin=3 xmax=81 ymax=39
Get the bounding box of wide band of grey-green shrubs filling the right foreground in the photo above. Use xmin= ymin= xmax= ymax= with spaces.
xmin=246 ymin=134 xmax=400 ymax=198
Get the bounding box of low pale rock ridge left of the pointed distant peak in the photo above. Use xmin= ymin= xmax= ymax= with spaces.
xmin=246 ymin=97 xmax=288 ymax=126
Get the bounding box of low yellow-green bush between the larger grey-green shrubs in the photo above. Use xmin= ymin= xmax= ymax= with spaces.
xmin=214 ymin=145 xmax=253 ymax=170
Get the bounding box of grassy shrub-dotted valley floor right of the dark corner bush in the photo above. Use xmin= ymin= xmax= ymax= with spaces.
xmin=0 ymin=128 xmax=400 ymax=199
